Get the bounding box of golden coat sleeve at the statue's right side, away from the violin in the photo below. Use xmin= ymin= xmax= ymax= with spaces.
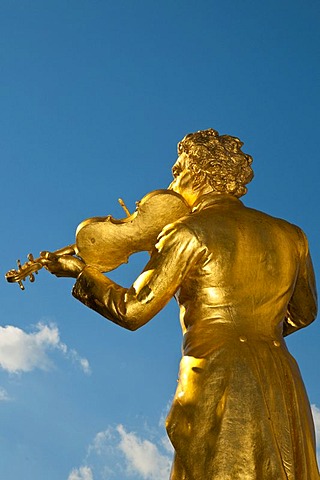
xmin=283 ymin=229 xmax=317 ymax=336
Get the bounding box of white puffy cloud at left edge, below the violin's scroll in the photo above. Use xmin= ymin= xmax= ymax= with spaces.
xmin=0 ymin=323 xmax=90 ymax=373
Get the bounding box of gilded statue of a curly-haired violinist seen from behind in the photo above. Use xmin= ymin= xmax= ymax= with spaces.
xmin=7 ymin=129 xmax=320 ymax=480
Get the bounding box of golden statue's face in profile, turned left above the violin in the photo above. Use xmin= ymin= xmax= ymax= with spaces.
xmin=168 ymin=153 xmax=202 ymax=206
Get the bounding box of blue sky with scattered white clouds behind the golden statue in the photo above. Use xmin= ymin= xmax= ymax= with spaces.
xmin=0 ymin=0 xmax=320 ymax=480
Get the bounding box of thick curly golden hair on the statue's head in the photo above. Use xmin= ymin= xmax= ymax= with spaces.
xmin=173 ymin=128 xmax=253 ymax=197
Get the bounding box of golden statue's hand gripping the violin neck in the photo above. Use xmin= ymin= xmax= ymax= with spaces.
xmin=40 ymin=252 xmax=85 ymax=278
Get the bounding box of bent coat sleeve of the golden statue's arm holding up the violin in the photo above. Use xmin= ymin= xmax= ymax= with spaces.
xmin=72 ymin=223 xmax=202 ymax=330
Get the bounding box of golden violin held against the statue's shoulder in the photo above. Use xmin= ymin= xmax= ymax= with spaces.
xmin=5 ymin=190 xmax=190 ymax=290
